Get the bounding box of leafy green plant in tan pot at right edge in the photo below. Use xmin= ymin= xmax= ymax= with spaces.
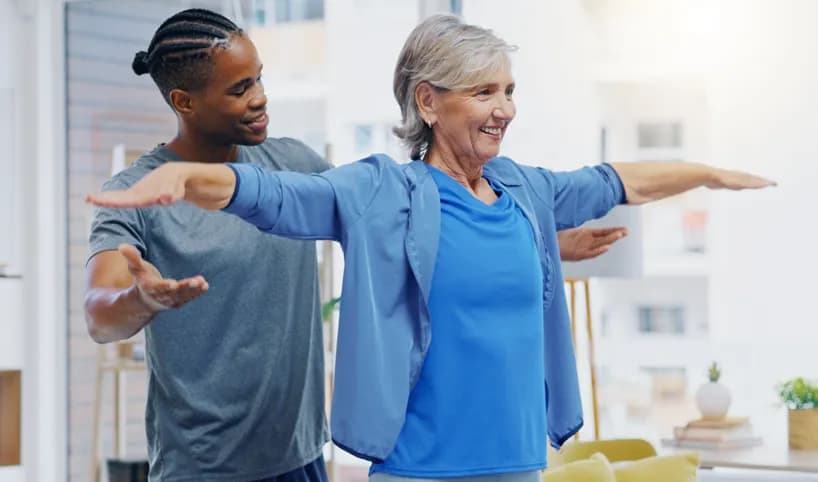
xmin=778 ymin=377 xmax=818 ymax=450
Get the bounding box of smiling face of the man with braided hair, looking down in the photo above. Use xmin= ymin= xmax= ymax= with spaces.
xmin=190 ymin=35 xmax=268 ymax=145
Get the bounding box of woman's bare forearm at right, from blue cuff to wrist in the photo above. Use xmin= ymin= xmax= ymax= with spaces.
xmin=611 ymin=162 xmax=718 ymax=204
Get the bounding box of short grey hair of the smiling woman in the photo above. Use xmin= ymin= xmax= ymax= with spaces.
xmin=392 ymin=15 xmax=516 ymax=159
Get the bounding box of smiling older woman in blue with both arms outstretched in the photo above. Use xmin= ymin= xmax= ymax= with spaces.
xmin=88 ymin=16 xmax=772 ymax=481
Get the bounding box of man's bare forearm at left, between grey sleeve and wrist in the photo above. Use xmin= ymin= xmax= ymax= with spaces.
xmin=85 ymin=285 xmax=159 ymax=343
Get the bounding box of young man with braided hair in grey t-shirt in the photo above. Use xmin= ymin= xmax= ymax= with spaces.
xmin=85 ymin=9 xmax=624 ymax=482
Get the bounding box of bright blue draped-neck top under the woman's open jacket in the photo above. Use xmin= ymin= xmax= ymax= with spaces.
xmin=372 ymin=166 xmax=546 ymax=477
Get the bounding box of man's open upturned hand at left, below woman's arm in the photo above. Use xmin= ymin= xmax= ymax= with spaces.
xmin=119 ymin=244 xmax=208 ymax=312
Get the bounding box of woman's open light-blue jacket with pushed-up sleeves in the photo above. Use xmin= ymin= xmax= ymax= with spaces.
xmin=225 ymin=154 xmax=625 ymax=462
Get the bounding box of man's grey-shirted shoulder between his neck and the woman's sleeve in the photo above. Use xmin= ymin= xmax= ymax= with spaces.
xmin=248 ymin=137 xmax=332 ymax=173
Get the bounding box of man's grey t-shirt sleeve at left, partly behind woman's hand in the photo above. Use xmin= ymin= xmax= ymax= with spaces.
xmin=85 ymin=178 xmax=147 ymax=264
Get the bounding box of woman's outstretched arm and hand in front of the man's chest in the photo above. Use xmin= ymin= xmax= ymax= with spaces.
xmin=86 ymin=156 xmax=385 ymax=240
